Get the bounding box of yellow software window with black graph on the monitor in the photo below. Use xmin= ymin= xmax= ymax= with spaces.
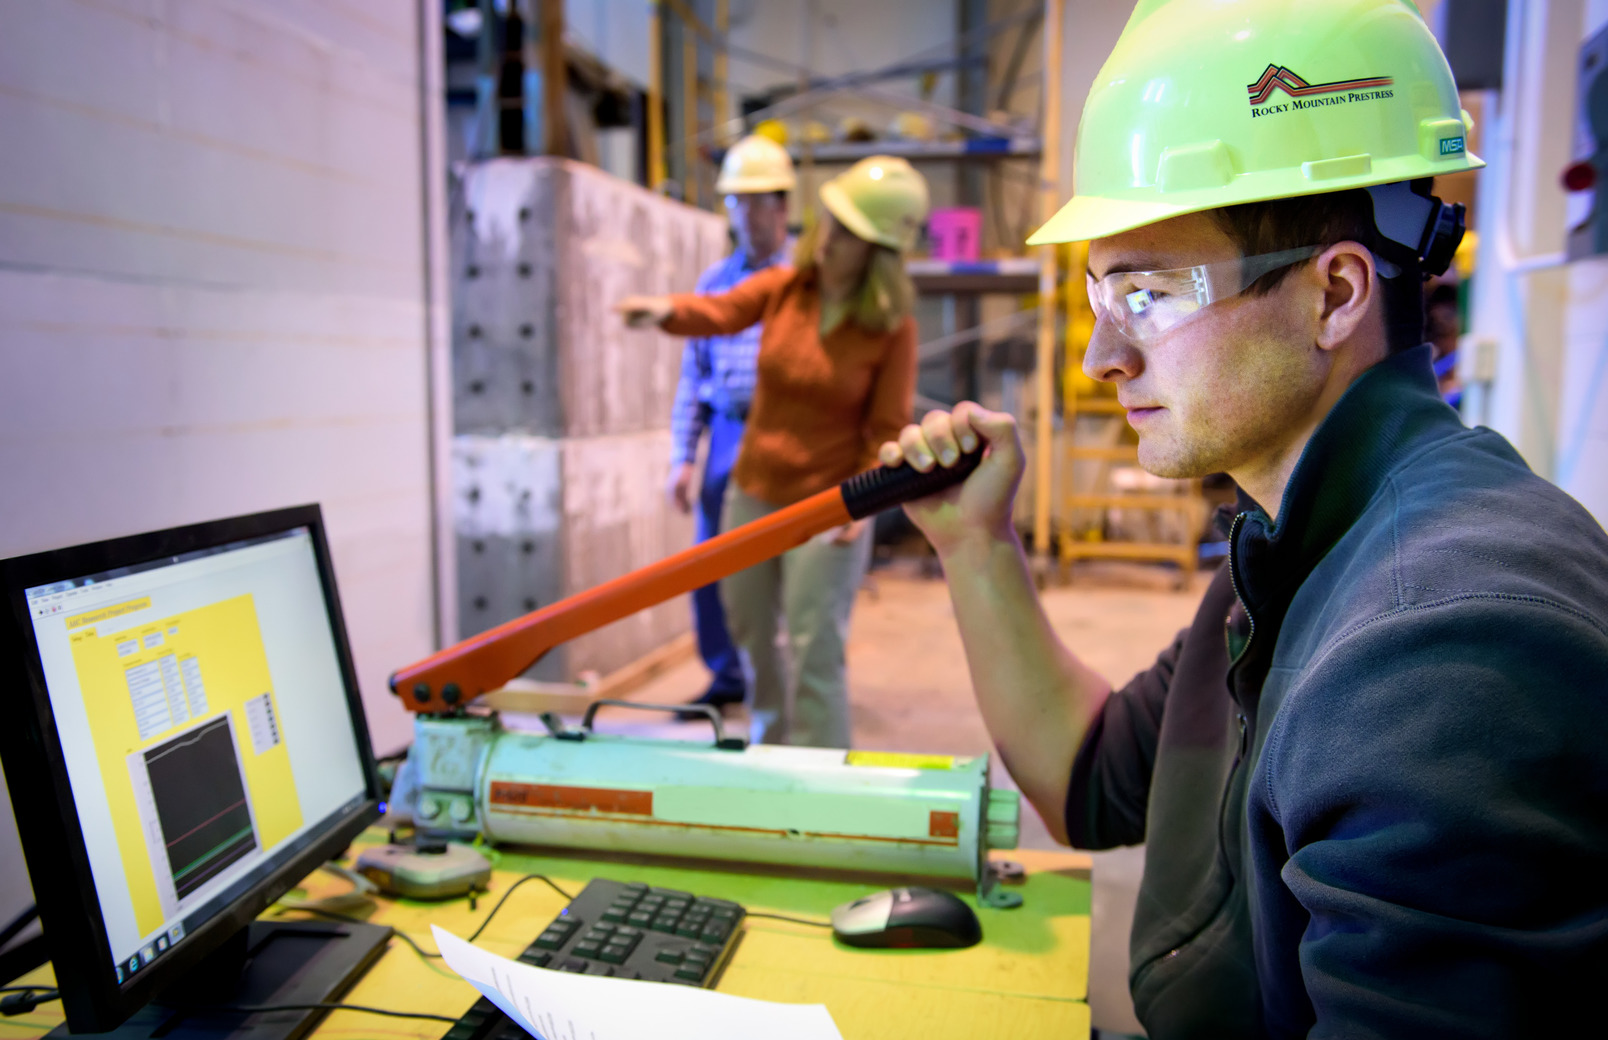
xmin=68 ymin=595 xmax=302 ymax=932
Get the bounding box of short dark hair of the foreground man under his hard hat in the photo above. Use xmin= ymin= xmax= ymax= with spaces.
xmin=1208 ymin=188 xmax=1425 ymax=354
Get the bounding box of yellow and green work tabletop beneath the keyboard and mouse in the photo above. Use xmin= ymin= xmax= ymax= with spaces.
xmin=0 ymin=833 xmax=1089 ymax=1040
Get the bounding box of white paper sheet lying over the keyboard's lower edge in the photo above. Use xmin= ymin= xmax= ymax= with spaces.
xmin=431 ymin=926 xmax=843 ymax=1040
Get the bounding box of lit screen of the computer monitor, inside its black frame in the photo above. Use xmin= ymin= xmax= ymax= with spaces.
xmin=7 ymin=511 xmax=373 ymax=1009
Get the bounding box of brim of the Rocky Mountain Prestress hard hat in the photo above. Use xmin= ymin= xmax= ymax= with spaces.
xmin=1028 ymin=153 xmax=1486 ymax=246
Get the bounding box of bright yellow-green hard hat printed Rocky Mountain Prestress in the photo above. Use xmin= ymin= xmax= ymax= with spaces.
xmin=1028 ymin=0 xmax=1484 ymax=244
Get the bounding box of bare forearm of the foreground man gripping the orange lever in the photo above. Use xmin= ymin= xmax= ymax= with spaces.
xmin=944 ymin=532 xmax=1111 ymax=841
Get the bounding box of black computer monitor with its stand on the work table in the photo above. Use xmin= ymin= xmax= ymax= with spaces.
xmin=0 ymin=506 xmax=389 ymax=1037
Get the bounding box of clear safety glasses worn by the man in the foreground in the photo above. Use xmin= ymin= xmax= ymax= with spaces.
xmin=1089 ymin=246 xmax=1323 ymax=342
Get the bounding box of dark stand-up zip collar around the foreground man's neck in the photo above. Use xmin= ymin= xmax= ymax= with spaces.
xmin=1230 ymin=346 xmax=1463 ymax=622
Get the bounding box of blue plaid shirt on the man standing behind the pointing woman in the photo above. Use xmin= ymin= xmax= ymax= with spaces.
xmin=671 ymin=238 xmax=793 ymax=465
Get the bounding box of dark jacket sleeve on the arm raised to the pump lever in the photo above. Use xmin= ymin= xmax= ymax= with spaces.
xmin=1066 ymin=629 xmax=1188 ymax=849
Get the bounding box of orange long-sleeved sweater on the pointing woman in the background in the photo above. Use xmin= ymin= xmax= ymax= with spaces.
xmin=662 ymin=267 xmax=917 ymax=505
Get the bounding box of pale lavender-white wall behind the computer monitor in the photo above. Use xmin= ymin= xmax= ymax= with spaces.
xmin=0 ymin=0 xmax=444 ymax=945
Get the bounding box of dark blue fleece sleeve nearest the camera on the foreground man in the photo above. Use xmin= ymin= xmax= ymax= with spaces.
xmin=1249 ymin=593 xmax=1608 ymax=1038
